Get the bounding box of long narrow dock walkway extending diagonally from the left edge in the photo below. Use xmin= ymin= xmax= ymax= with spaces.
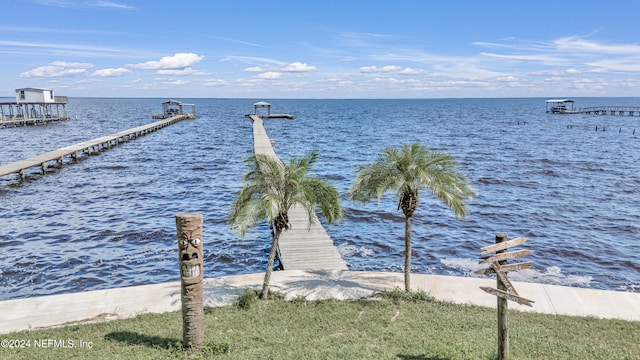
xmin=0 ymin=115 xmax=187 ymax=179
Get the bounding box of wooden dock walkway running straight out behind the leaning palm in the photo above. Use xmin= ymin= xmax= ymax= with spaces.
xmin=249 ymin=115 xmax=347 ymax=270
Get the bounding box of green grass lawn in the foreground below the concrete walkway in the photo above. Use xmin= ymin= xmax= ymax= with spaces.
xmin=0 ymin=293 xmax=640 ymax=360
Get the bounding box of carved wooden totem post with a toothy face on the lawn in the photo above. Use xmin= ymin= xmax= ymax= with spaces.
xmin=176 ymin=214 xmax=204 ymax=348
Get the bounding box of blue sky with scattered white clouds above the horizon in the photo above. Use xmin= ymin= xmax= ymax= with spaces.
xmin=0 ymin=0 xmax=640 ymax=98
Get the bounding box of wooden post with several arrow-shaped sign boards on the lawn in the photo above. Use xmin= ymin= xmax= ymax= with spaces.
xmin=475 ymin=234 xmax=533 ymax=360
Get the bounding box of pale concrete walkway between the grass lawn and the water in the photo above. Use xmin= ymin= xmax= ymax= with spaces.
xmin=0 ymin=270 xmax=640 ymax=334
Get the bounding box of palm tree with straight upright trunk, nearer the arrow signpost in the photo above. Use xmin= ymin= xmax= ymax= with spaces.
xmin=348 ymin=143 xmax=475 ymax=291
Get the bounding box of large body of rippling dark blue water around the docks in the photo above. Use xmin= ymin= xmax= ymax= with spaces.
xmin=0 ymin=98 xmax=640 ymax=300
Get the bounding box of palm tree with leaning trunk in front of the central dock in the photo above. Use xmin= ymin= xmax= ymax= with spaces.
xmin=227 ymin=152 xmax=344 ymax=298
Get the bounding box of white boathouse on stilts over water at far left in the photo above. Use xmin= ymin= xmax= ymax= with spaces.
xmin=0 ymin=88 xmax=69 ymax=127
